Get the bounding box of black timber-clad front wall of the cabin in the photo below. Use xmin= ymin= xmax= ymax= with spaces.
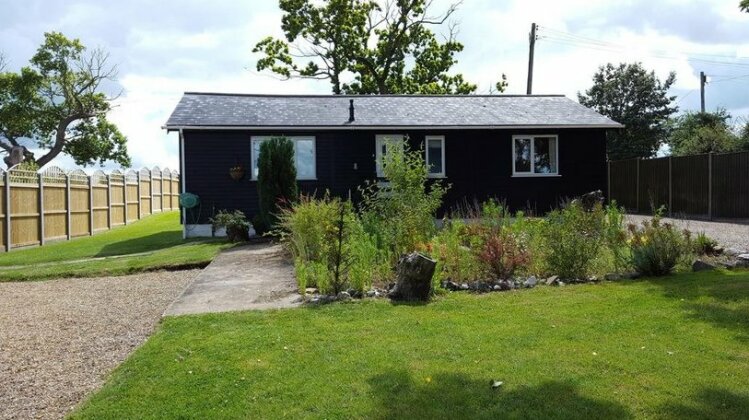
xmin=184 ymin=128 xmax=607 ymax=224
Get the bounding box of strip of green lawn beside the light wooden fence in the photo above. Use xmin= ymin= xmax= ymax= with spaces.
xmin=0 ymin=212 xmax=228 ymax=281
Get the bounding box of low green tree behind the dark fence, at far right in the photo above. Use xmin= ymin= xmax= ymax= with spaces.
xmin=668 ymin=109 xmax=749 ymax=156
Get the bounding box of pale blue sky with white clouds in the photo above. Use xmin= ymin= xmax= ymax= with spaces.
xmin=0 ymin=0 xmax=749 ymax=169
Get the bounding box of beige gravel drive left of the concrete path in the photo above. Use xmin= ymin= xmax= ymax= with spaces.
xmin=0 ymin=270 xmax=200 ymax=419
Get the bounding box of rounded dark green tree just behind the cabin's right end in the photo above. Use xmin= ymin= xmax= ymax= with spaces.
xmin=578 ymin=63 xmax=678 ymax=159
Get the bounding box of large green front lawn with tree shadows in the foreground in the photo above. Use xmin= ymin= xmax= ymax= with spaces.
xmin=73 ymin=271 xmax=749 ymax=419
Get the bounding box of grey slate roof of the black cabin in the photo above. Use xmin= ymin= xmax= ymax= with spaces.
xmin=165 ymin=92 xmax=621 ymax=129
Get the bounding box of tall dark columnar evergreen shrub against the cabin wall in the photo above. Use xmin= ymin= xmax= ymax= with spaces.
xmin=253 ymin=137 xmax=297 ymax=234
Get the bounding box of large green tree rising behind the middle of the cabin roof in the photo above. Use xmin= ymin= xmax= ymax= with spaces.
xmin=253 ymin=0 xmax=482 ymax=94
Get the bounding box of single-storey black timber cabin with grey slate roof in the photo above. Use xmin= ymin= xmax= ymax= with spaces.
xmin=165 ymin=92 xmax=622 ymax=236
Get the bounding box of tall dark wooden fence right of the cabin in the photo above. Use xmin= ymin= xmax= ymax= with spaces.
xmin=608 ymin=152 xmax=749 ymax=219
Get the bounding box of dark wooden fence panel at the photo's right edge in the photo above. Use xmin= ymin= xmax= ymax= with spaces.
xmin=712 ymin=152 xmax=749 ymax=218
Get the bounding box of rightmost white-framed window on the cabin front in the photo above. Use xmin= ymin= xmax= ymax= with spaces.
xmin=512 ymin=135 xmax=559 ymax=176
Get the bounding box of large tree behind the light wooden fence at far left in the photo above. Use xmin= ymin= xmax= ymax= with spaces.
xmin=0 ymin=32 xmax=130 ymax=166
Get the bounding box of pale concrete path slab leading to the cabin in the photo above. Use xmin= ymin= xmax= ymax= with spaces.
xmin=164 ymin=244 xmax=302 ymax=316
